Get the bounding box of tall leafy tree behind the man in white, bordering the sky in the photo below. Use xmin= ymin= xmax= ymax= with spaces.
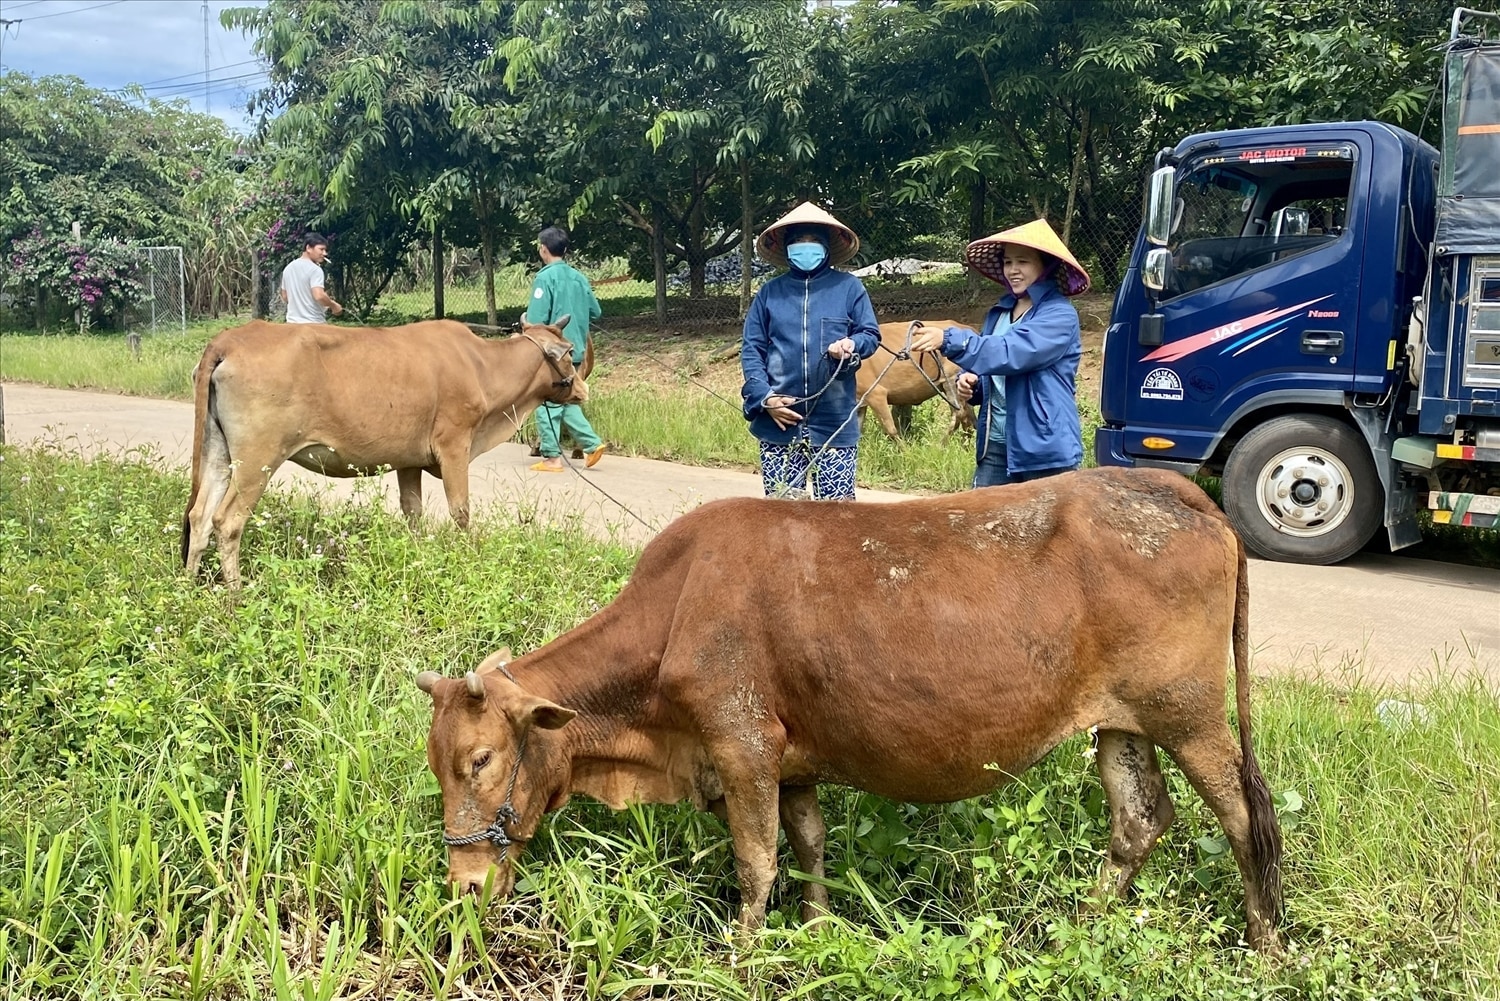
xmin=224 ymin=0 xmax=543 ymax=323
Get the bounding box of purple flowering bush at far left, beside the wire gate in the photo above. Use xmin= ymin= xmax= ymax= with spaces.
xmin=8 ymin=230 xmax=146 ymax=330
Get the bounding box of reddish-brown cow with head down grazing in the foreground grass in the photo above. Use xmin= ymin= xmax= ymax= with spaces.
xmin=417 ymin=468 xmax=1281 ymax=950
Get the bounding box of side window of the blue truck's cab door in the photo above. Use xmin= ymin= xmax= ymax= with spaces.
xmin=1166 ymin=144 xmax=1355 ymax=299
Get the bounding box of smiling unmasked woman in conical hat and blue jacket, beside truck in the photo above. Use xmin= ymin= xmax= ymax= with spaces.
xmin=912 ymin=219 xmax=1089 ymax=486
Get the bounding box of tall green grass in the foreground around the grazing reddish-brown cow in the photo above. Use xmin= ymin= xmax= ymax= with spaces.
xmin=0 ymin=447 xmax=1500 ymax=1001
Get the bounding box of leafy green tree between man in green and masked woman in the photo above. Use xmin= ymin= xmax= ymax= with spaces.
xmin=500 ymin=0 xmax=831 ymax=315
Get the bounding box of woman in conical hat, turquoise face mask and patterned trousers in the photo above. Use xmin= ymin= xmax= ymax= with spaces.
xmin=740 ymin=201 xmax=881 ymax=500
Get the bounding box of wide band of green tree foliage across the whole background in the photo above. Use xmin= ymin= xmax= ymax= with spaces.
xmin=0 ymin=0 xmax=1496 ymax=328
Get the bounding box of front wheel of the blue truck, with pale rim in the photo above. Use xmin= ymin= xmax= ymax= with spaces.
xmin=1224 ymin=414 xmax=1385 ymax=564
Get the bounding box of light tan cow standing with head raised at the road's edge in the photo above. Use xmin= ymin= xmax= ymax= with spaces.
xmin=183 ymin=317 xmax=588 ymax=587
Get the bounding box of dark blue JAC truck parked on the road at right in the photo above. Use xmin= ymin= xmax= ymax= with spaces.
xmin=1095 ymin=8 xmax=1500 ymax=563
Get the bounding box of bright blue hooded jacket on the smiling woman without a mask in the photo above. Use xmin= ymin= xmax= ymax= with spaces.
xmin=942 ymin=279 xmax=1083 ymax=474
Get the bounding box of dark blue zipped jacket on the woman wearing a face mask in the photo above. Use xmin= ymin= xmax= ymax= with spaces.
xmin=740 ymin=263 xmax=881 ymax=449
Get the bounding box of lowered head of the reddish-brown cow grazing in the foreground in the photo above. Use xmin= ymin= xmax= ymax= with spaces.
xmin=417 ymin=650 xmax=578 ymax=897
